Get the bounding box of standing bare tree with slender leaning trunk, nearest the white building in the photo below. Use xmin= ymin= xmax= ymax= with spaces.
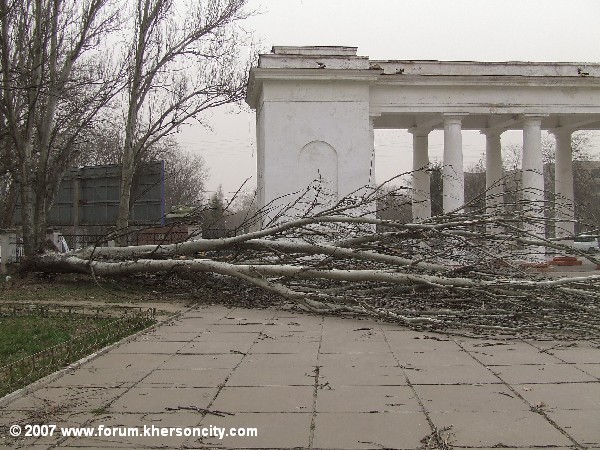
xmin=117 ymin=0 xmax=249 ymax=243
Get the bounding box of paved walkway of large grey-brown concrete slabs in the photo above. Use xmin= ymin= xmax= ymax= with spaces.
xmin=0 ymin=306 xmax=600 ymax=450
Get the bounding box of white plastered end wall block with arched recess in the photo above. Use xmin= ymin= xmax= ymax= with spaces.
xmin=257 ymin=82 xmax=372 ymax=218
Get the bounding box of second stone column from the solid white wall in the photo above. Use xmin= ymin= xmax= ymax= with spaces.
xmin=442 ymin=116 xmax=465 ymax=214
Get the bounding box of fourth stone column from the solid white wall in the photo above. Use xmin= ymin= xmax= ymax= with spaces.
xmin=521 ymin=116 xmax=545 ymax=261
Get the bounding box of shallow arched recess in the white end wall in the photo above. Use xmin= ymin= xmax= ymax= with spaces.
xmin=298 ymin=141 xmax=338 ymax=201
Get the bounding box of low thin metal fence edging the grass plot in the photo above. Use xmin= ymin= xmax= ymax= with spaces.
xmin=0 ymin=303 xmax=156 ymax=396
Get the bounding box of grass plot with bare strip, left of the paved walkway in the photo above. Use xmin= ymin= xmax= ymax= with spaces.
xmin=0 ymin=274 xmax=162 ymax=397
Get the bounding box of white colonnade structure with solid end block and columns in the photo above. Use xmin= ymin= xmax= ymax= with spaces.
xmin=246 ymin=47 xmax=600 ymax=241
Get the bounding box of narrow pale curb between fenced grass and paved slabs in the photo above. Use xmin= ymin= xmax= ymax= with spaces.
xmin=0 ymin=306 xmax=196 ymax=408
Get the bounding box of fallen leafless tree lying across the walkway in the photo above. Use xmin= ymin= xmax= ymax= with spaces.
xmin=18 ymin=188 xmax=600 ymax=339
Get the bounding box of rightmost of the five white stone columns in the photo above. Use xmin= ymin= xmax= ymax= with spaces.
xmin=553 ymin=129 xmax=575 ymax=246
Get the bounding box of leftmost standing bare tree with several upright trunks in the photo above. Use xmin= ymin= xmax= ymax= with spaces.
xmin=0 ymin=0 xmax=118 ymax=256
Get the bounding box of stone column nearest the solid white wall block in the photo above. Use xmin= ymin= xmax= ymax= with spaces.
xmin=408 ymin=128 xmax=431 ymax=222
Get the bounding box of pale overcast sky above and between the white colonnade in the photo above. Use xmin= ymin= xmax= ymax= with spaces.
xmin=179 ymin=0 xmax=600 ymax=196
